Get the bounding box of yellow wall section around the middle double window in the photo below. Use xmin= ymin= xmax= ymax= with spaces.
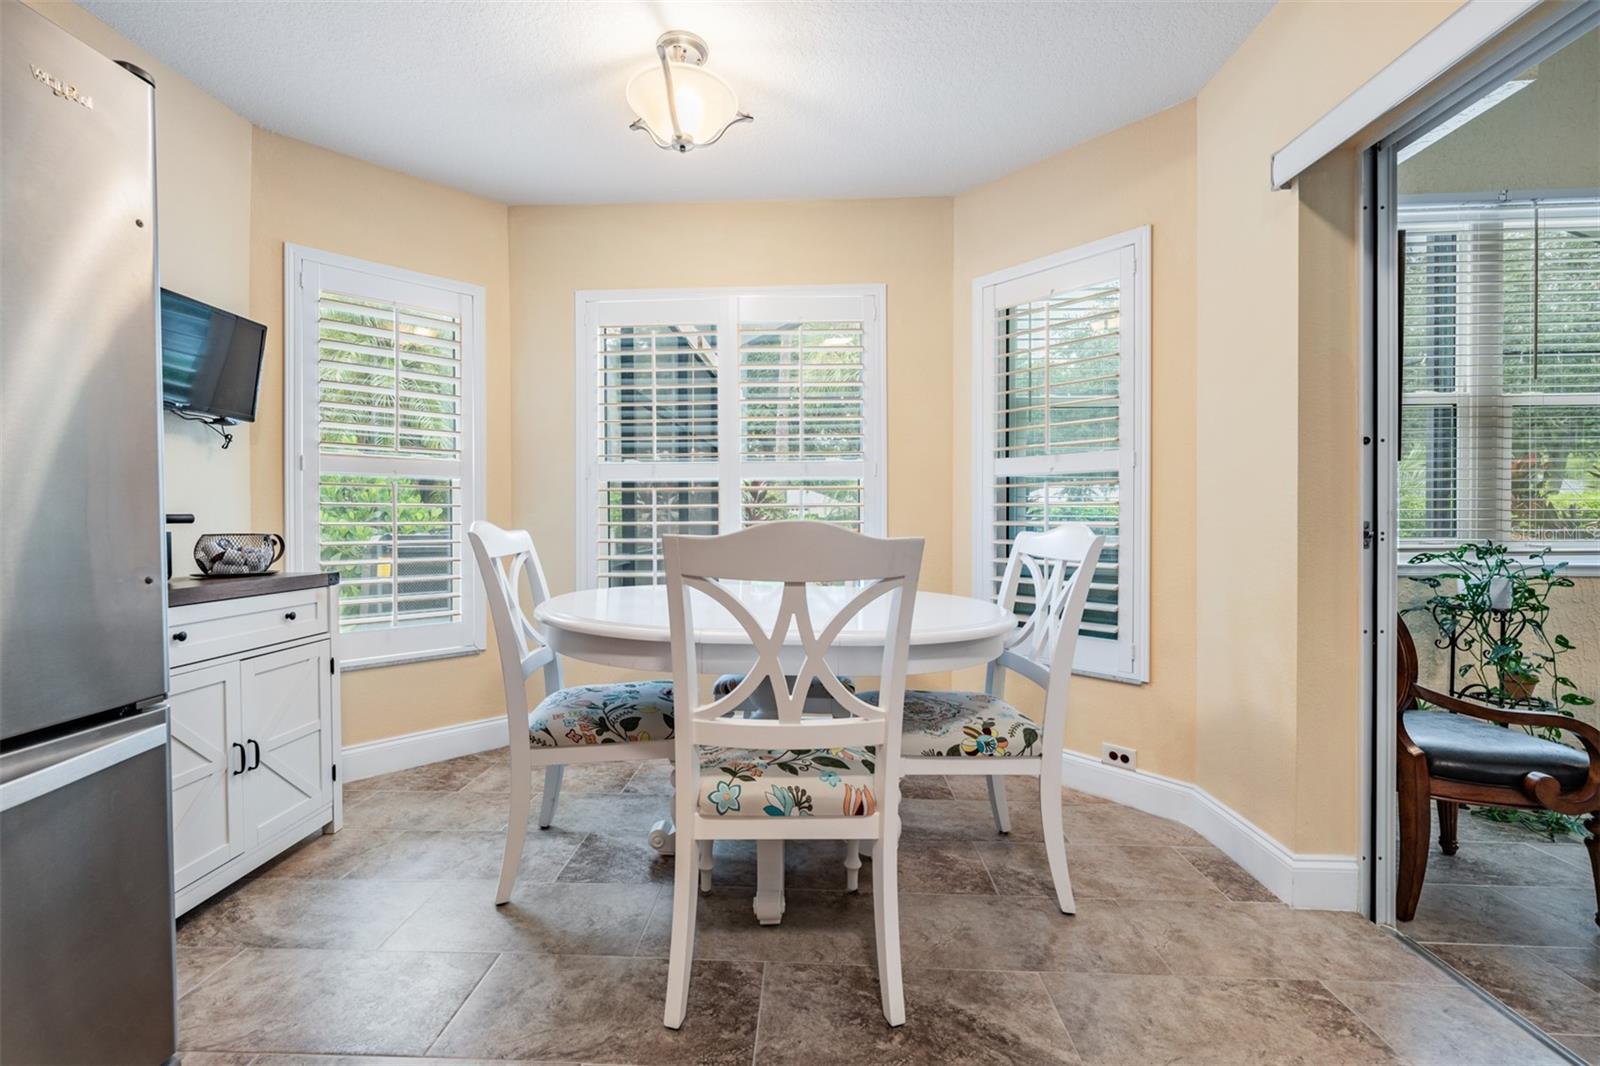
xmin=510 ymin=198 xmax=952 ymax=665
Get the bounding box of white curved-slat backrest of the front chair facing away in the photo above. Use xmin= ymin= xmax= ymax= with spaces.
xmin=662 ymin=520 xmax=922 ymax=758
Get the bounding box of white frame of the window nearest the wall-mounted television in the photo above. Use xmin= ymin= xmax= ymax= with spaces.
xmin=283 ymin=243 xmax=486 ymax=671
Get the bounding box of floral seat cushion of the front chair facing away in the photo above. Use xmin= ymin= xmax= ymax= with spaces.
xmin=699 ymin=747 xmax=878 ymax=818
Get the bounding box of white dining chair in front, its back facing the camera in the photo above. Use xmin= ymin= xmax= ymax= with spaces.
xmin=662 ymin=522 xmax=922 ymax=1029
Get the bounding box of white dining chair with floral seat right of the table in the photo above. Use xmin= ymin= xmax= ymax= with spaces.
xmin=864 ymin=523 xmax=1106 ymax=914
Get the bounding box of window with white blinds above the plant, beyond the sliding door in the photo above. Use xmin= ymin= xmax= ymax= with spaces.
xmin=1398 ymin=198 xmax=1600 ymax=559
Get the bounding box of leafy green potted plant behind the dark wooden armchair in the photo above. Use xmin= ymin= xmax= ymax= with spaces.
xmin=1405 ymin=541 xmax=1594 ymax=839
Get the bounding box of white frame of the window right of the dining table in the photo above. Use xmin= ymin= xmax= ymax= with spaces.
xmin=971 ymin=226 xmax=1150 ymax=685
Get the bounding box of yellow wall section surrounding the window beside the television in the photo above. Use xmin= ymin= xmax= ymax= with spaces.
xmin=250 ymin=130 xmax=512 ymax=744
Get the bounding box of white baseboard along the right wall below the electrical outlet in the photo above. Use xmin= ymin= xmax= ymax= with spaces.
xmin=1061 ymin=751 xmax=1362 ymax=911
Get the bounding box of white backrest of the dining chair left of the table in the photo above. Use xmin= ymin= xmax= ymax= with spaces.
xmin=467 ymin=520 xmax=562 ymax=738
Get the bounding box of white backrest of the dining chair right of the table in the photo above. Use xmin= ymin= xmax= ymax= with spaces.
xmin=987 ymin=522 xmax=1106 ymax=751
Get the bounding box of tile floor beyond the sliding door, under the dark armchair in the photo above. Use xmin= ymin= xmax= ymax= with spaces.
xmin=1398 ymin=800 xmax=1600 ymax=1063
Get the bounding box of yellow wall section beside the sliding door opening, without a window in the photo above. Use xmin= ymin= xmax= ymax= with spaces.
xmin=1194 ymin=2 xmax=1456 ymax=855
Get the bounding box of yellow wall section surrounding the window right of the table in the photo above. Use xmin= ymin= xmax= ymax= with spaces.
xmin=946 ymin=101 xmax=1195 ymax=779
